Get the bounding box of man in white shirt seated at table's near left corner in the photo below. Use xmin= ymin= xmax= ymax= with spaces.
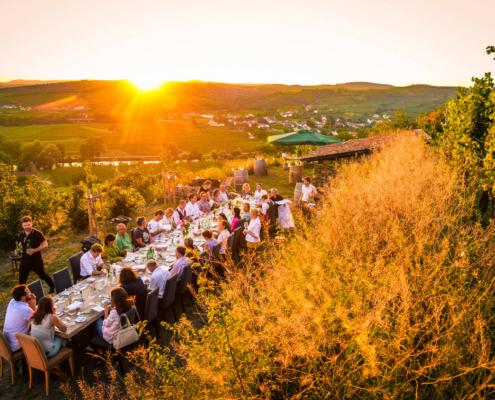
xmin=0 ymin=285 xmax=36 ymax=350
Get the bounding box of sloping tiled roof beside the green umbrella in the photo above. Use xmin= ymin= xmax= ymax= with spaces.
xmin=301 ymin=135 xmax=397 ymax=161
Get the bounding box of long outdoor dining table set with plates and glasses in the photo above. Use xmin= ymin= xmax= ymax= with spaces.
xmin=51 ymin=207 xmax=231 ymax=339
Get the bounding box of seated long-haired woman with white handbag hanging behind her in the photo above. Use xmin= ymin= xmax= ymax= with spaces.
xmin=92 ymin=287 xmax=133 ymax=346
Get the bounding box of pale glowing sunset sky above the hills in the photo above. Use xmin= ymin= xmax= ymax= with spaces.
xmin=0 ymin=0 xmax=495 ymax=85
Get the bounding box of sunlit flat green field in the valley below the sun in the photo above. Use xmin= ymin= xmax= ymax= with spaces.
xmin=0 ymin=121 xmax=264 ymax=156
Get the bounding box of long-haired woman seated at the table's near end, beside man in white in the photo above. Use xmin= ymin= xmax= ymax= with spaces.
xmin=31 ymin=296 xmax=67 ymax=358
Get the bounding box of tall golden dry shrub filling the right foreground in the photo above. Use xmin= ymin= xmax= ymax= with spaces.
xmin=70 ymin=137 xmax=495 ymax=399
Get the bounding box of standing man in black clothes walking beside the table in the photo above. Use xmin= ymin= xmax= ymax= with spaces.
xmin=19 ymin=216 xmax=55 ymax=293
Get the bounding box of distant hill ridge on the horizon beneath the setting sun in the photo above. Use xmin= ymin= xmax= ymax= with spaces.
xmin=0 ymin=80 xmax=456 ymax=115
